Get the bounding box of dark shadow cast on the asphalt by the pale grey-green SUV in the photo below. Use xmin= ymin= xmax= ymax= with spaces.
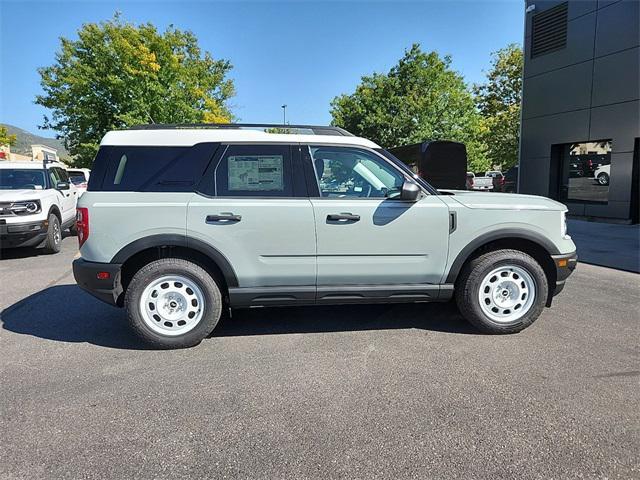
xmin=0 ymin=285 xmax=478 ymax=350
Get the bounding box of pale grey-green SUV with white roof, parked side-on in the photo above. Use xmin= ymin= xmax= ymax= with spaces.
xmin=73 ymin=125 xmax=576 ymax=348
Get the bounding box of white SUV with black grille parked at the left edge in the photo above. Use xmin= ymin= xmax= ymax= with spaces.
xmin=0 ymin=161 xmax=78 ymax=253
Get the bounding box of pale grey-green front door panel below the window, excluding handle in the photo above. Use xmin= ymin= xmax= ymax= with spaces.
xmin=311 ymin=196 xmax=449 ymax=285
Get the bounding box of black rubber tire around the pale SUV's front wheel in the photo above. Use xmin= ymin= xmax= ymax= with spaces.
xmin=455 ymin=250 xmax=549 ymax=334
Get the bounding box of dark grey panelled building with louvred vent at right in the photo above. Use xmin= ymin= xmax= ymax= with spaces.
xmin=518 ymin=0 xmax=640 ymax=223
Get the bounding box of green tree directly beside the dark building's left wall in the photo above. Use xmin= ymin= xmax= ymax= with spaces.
xmin=473 ymin=44 xmax=524 ymax=169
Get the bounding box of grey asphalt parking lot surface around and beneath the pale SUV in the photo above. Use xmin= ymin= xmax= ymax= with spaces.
xmin=0 ymin=237 xmax=640 ymax=479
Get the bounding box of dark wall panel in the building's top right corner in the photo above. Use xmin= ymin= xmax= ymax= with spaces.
xmin=596 ymin=0 xmax=640 ymax=57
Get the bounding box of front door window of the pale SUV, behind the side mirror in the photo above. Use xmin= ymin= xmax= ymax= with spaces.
xmin=311 ymin=146 xmax=404 ymax=198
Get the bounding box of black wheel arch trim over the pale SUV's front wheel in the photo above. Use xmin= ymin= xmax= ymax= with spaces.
xmin=446 ymin=229 xmax=560 ymax=305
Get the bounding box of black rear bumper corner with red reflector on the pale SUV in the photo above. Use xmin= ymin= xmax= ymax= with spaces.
xmin=73 ymin=258 xmax=122 ymax=306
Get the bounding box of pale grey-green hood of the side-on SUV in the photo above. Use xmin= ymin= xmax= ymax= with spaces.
xmin=444 ymin=190 xmax=567 ymax=211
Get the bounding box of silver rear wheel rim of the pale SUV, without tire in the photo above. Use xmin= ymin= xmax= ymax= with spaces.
xmin=140 ymin=275 xmax=205 ymax=337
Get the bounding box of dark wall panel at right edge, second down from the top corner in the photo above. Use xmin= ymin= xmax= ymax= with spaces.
xmin=592 ymin=47 xmax=640 ymax=107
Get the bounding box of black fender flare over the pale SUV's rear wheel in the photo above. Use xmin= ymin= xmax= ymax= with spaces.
xmin=110 ymin=233 xmax=238 ymax=288
